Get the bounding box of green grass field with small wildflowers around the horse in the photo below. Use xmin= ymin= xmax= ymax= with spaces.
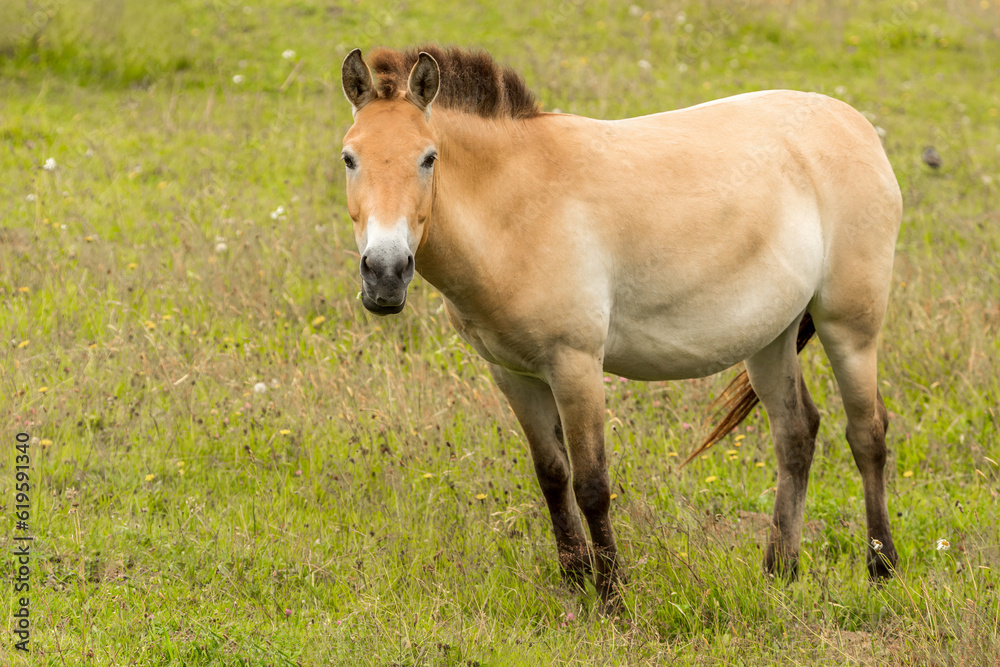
xmin=0 ymin=0 xmax=1000 ymax=666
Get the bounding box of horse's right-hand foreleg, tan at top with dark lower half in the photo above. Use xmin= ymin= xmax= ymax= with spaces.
xmin=550 ymin=353 xmax=619 ymax=605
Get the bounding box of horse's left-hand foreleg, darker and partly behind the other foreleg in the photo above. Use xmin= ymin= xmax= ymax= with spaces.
xmin=490 ymin=364 xmax=590 ymax=588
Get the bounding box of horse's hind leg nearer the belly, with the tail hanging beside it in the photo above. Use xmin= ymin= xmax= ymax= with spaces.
xmin=746 ymin=320 xmax=819 ymax=579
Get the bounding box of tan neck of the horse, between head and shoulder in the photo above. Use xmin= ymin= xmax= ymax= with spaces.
xmin=416 ymin=109 xmax=540 ymax=309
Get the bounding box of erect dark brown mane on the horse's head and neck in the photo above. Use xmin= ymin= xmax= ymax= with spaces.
xmin=369 ymin=45 xmax=541 ymax=118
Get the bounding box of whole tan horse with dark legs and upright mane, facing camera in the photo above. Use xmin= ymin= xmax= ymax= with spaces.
xmin=343 ymin=47 xmax=902 ymax=601
